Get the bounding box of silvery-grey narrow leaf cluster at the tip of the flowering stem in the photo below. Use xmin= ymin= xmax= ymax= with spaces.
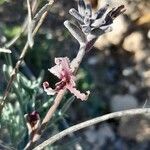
xmin=64 ymin=0 xmax=125 ymax=50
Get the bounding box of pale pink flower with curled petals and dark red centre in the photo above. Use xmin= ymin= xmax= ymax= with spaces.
xmin=43 ymin=57 xmax=90 ymax=100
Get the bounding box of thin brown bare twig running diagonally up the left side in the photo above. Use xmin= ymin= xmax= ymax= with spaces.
xmin=0 ymin=0 xmax=54 ymax=114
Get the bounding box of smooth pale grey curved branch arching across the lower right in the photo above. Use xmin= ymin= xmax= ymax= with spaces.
xmin=33 ymin=108 xmax=150 ymax=150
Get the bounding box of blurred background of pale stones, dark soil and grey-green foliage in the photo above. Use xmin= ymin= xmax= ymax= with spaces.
xmin=0 ymin=0 xmax=150 ymax=150
